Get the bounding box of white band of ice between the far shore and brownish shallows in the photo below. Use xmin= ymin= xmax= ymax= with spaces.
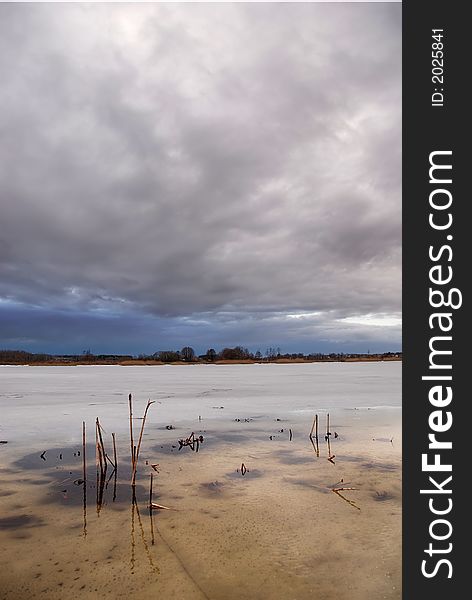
xmin=0 ymin=362 xmax=401 ymax=449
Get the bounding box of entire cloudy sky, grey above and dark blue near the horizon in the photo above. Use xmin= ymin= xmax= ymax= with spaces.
xmin=0 ymin=3 xmax=401 ymax=354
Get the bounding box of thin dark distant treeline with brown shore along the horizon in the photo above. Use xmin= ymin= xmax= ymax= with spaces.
xmin=0 ymin=346 xmax=402 ymax=365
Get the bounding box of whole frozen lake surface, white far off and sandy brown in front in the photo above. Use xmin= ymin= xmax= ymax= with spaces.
xmin=0 ymin=363 xmax=401 ymax=600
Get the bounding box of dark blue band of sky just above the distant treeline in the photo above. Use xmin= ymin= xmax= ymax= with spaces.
xmin=0 ymin=305 xmax=401 ymax=355
